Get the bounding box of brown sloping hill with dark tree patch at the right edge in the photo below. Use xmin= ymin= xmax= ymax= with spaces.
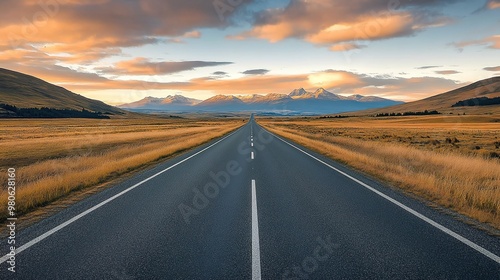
xmin=351 ymin=77 xmax=500 ymax=115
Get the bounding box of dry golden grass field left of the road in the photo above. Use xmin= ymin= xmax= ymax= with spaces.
xmin=0 ymin=119 xmax=243 ymax=221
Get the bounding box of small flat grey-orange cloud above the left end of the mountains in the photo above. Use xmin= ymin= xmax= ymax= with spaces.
xmin=99 ymin=57 xmax=232 ymax=75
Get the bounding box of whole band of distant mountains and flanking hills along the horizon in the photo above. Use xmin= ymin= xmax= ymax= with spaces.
xmin=0 ymin=68 xmax=500 ymax=118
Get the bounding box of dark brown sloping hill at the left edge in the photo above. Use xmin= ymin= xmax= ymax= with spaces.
xmin=0 ymin=68 xmax=128 ymax=115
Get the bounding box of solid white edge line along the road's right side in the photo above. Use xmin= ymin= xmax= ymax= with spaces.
xmin=268 ymin=131 xmax=500 ymax=264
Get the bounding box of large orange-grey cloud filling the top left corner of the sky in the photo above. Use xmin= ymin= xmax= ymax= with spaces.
xmin=0 ymin=0 xmax=251 ymax=62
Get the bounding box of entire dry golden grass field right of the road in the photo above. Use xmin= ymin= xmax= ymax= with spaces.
xmin=258 ymin=116 xmax=500 ymax=229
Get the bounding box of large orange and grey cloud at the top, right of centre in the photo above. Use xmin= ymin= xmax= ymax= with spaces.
xmin=229 ymin=0 xmax=454 ymax=45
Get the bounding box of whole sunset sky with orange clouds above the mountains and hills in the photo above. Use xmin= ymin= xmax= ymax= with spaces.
xmin=0 ymin=0 xmax=500 ymax=105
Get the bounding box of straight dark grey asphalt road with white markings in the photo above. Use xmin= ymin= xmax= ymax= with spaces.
xmin=0 ymin=118 xmax=500 ymax=279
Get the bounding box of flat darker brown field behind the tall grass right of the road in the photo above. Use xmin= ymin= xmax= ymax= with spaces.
xmin=266 ymin=115 xmax=500 ymax=158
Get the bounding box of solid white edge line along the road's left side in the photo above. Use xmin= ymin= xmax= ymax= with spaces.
xmin=0 ymin=127 xmax=241 ymax=264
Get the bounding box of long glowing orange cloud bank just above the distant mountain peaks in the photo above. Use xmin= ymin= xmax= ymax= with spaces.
xmin=51 ymin=67 xmax=463 ymax=101
